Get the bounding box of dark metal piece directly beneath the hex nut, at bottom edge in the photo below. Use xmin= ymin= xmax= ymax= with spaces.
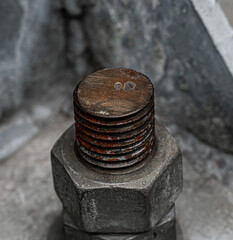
xmin=63 ymin=207 xmax=176 ymax=240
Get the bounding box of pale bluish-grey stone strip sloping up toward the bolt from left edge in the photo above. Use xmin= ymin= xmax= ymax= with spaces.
xmin=0 ymin=81 xmax=77 ymax=161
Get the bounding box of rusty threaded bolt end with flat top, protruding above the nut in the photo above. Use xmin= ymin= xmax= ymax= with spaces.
xmin=74 ymin=68 xmax=154 ymax=169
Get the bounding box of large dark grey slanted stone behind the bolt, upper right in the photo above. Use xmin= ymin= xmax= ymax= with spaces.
xmin=78 ymin=0 xmax=233 ymax=151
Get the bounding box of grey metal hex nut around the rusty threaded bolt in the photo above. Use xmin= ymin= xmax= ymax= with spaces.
xmin=51 ymin=120 xmax=182 ymax=233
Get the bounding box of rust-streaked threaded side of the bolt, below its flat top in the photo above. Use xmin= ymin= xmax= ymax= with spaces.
xmin=74 ymin=67 xmax=154 ymax=169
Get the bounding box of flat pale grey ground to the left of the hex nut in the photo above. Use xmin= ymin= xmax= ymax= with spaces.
xmin=0 ymin=117 xmax=71 ymax=240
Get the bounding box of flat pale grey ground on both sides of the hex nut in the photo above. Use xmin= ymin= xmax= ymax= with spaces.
xmin=0 ymin=116 xmax=233 ymax=240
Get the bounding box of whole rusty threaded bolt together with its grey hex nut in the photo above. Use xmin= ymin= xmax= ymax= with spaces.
xmin=51 ymin=68 xmax=182 ymax=240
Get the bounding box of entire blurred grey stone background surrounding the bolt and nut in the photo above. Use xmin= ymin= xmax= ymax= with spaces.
xmin=0 ymin=0 xmax=233 ymax=240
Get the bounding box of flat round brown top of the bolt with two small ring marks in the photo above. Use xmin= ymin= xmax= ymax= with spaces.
xmin=75 ymin=68 xmax=153 ymax=118
